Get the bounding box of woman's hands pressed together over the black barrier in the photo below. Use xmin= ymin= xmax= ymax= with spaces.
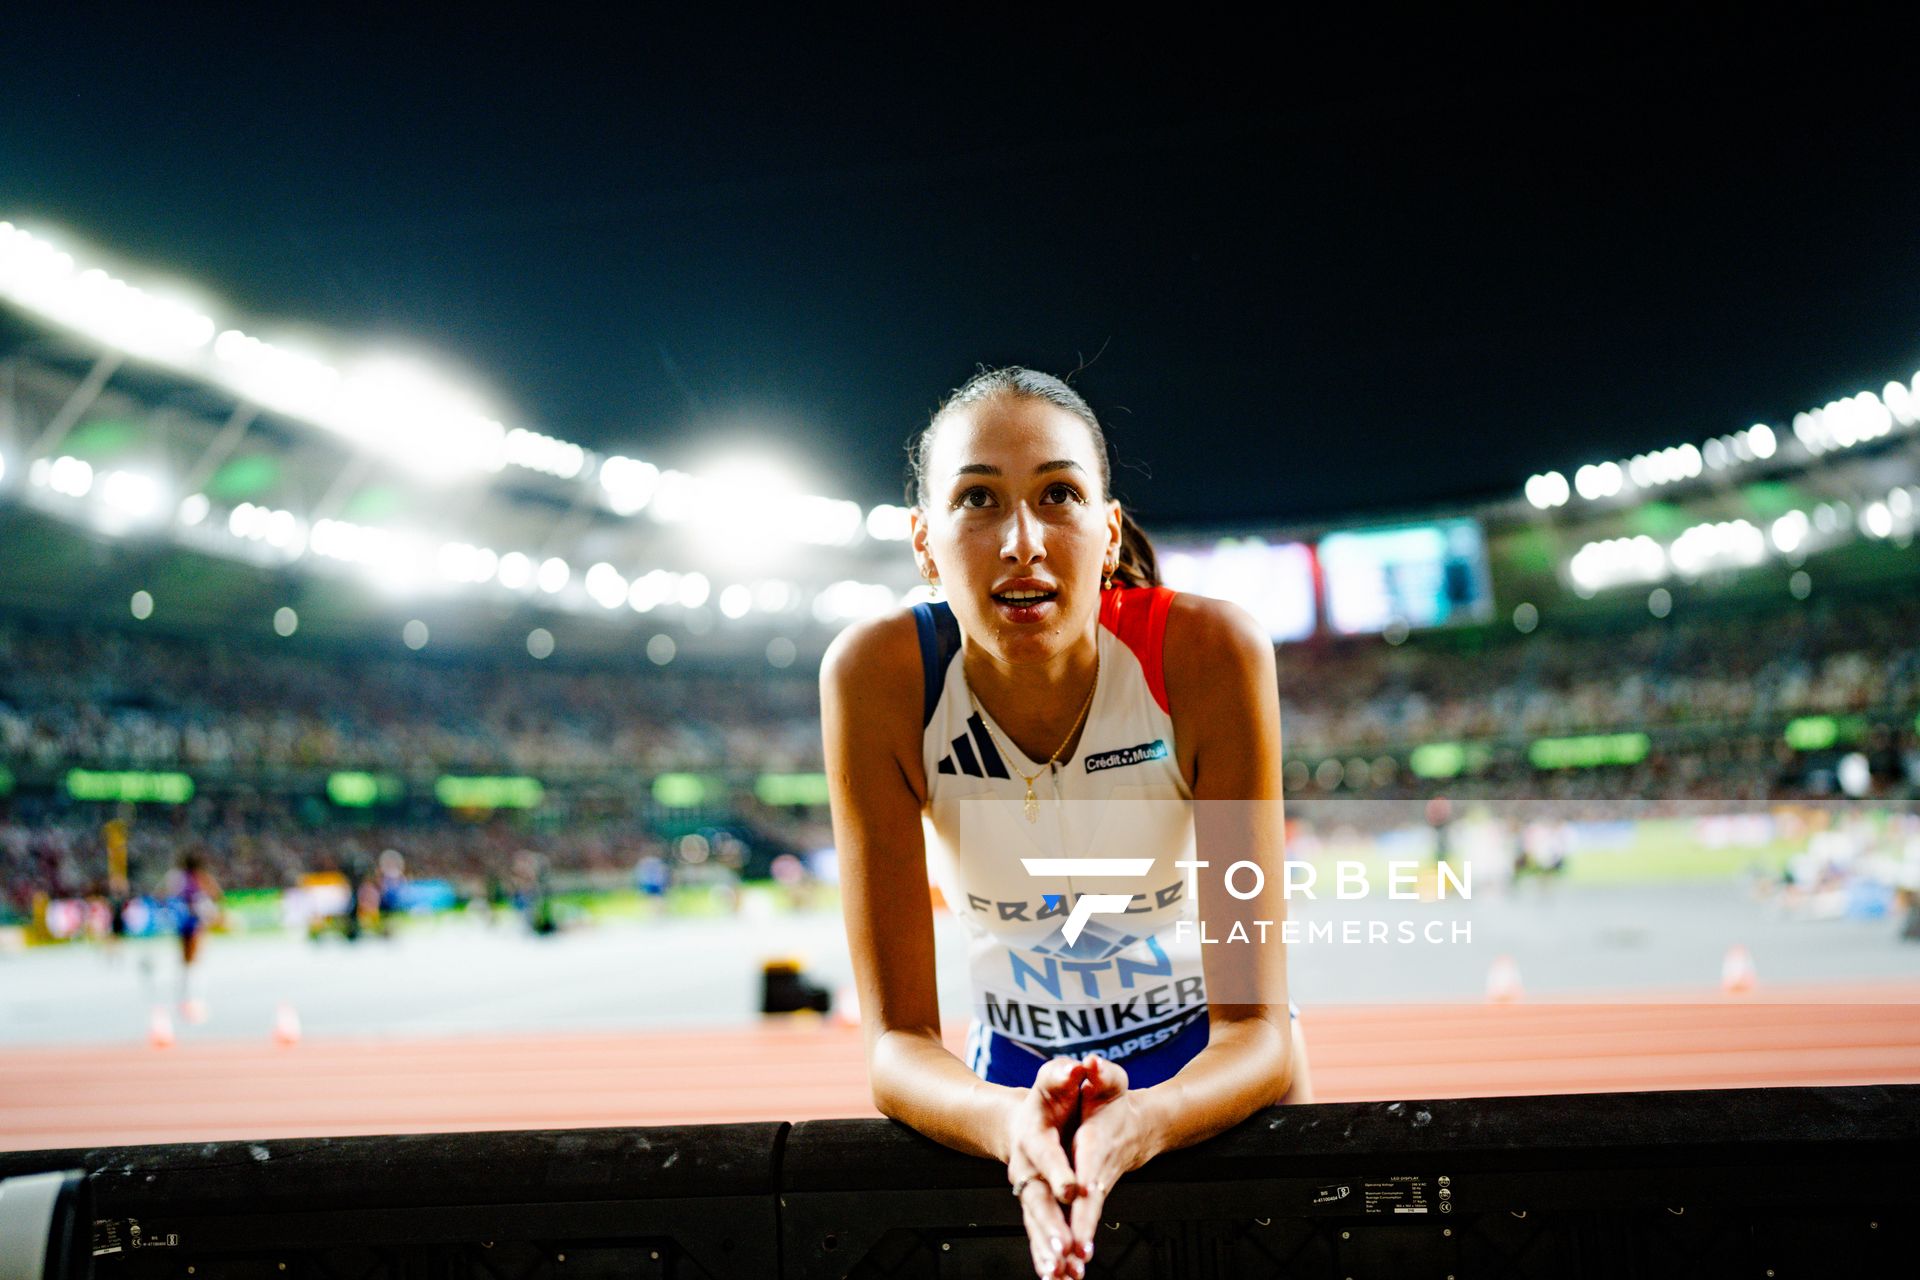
xmin=1006 ymin=1054 xmax=1154 ymax=1280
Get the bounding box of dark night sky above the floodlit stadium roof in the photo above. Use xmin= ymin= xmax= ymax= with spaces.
xmin=0 ymin=8 xmax=1920 ymax=524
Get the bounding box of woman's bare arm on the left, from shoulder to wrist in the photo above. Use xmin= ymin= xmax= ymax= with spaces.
xmin=820 ymin=614 xmax=1029 ymax=1163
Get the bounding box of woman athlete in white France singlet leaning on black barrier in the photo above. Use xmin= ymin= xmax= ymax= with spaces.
xmin=820 ymin=367 xmax=1309 ymax=1276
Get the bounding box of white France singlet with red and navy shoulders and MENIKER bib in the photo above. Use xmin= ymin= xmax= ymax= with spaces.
xmin=914 ymin=587 xmax=1206 ymax=1059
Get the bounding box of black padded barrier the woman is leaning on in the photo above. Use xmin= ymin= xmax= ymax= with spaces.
xmin=0 ymin=1086 xmax=1920 ymax=1280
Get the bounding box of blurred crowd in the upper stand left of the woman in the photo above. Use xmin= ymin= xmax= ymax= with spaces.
xmin=0 ymin=622 xmax=820 ymax=775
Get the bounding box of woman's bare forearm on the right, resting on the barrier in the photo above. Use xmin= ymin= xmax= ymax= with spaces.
xmin=1135 ymin=1017 xmax=1292 ymax=1151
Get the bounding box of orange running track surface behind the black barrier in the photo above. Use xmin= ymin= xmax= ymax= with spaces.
xmin=0 ymin=984 xmax=1920 ymax=1150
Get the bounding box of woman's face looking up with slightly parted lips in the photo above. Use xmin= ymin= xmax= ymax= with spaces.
xmin=914 ymin=395 xmax=1119 ymax=664
